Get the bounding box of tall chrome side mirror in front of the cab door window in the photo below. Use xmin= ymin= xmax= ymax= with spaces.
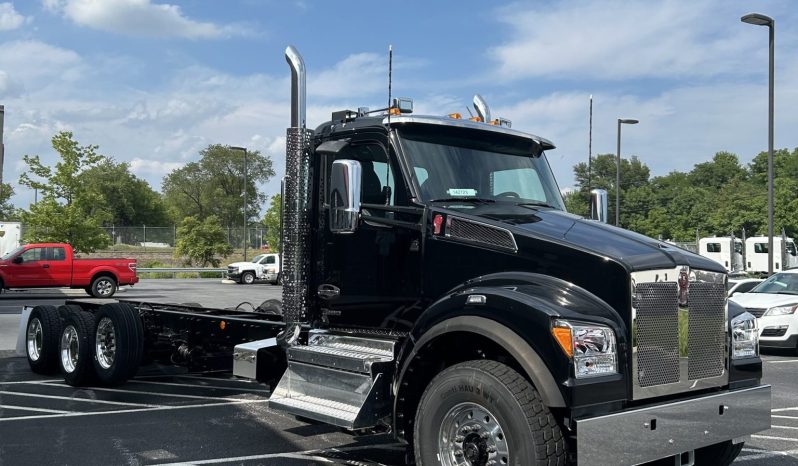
xmin=330 ymin=160 xmax=362 ymax=234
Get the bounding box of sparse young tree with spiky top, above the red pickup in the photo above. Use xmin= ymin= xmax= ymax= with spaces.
xmin=19 ymin=131 xmax=111 ymax=252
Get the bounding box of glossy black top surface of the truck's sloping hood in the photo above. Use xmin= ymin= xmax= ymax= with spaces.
xmin=473 ymin=206 xmax=726 ymax=273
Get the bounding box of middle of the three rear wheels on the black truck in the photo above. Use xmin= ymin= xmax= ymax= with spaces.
xmin=59 ymin=310 xmax=96 ymax=387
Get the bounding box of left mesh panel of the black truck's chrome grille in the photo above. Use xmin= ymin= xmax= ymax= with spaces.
xmin=635 ymin=282 xmax=679 ymax=387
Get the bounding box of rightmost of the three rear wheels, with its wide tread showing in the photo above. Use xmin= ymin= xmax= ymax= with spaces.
xmin=94 ymin=303 xmax=144 ymax=385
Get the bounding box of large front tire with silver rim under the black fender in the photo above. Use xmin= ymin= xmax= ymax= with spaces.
xmin=413 ymin=360 xmax=566 ymax=466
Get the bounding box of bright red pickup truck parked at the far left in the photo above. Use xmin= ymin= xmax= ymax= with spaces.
xmin=0 ymin=243 xmax=139 ymax=298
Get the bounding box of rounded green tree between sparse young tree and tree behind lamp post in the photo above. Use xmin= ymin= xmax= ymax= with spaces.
xmin=79 ymin=159 xmax=171 ymax=226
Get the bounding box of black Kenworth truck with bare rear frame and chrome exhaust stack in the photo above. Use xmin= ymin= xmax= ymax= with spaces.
xmin=21 ymin=47 xmax=770 ymax=466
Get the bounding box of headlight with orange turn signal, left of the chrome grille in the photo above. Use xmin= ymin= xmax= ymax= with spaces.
xmin=551 ymin=320 xmax=618 ymax=379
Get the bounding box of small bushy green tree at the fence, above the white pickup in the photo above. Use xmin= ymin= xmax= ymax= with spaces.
xmin=174 ymin=215 xmax=233 ymax=267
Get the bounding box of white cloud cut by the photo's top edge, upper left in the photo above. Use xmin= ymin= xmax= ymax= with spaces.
xmin=44 ymin=0 xmax=236 ymax=39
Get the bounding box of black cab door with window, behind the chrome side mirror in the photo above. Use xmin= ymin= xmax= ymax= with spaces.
xmin=316 ymin=140 xmax=423 ymax=329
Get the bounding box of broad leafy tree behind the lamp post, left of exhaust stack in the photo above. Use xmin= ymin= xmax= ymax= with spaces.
xmin=161 ymin=144 xmax=274 ymax=225
